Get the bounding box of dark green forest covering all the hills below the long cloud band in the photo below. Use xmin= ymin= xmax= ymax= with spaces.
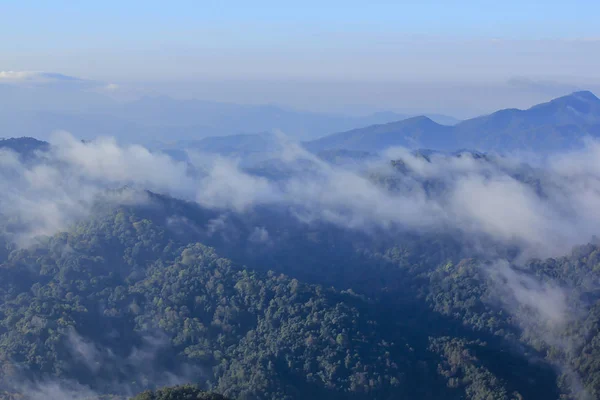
xmin=0 ymin=188 xmax=600 ymax=399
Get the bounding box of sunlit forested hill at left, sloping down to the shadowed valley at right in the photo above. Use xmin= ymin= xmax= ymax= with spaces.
xmin=0 ymin=195 xmax=464 ymax=399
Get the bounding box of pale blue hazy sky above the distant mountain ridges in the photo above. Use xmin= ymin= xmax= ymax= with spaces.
xmin=0 ymin=0 xmax=600 ymax=117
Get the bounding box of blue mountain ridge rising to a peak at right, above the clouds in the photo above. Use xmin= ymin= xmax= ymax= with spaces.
xmin=306 ymin=91 xmax=600 ymax=152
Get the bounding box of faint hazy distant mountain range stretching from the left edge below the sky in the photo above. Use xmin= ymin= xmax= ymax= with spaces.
xmin=0 ymin=80 xmax=456 ymax=148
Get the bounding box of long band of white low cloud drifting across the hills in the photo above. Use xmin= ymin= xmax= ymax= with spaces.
xmin=5 ymin=133 xmax=600 ymax=257
